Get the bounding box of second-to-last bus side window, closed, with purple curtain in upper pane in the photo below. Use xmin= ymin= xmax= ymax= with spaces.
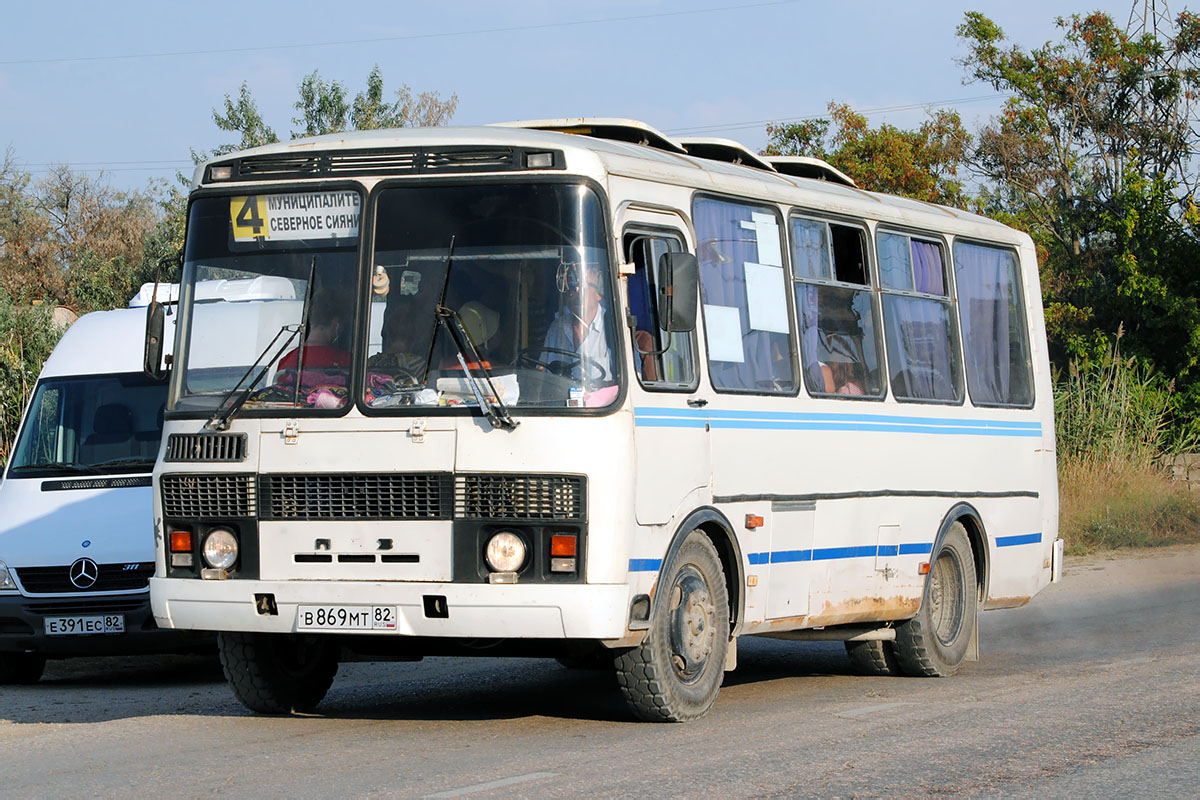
xmin=877 ymin=233 xmax=962 ymax=403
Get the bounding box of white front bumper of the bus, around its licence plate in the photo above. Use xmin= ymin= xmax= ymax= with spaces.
xmin=150 ymin=578 xmax=629 ymax=640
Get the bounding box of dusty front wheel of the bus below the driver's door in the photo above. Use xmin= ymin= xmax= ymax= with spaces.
xmin=614 ymin=530 xmax=730 ymax=722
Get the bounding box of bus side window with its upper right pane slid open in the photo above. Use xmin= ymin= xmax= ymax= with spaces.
xmin=791 ymin=217 xmax=883 ymax=398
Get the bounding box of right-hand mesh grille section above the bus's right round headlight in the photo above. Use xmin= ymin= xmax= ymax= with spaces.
xmin=455 ymin=474 xmax=587 ymax=522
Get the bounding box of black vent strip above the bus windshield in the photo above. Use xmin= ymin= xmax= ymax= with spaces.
xmin=208 ymin=146 xmax=564 ymax=184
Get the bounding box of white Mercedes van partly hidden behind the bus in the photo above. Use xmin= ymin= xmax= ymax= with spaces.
xmin=0 ymin=291 xmax=196 ymax=684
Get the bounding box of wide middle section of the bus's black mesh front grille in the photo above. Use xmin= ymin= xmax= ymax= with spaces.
xmin=262 ymin=473 xmax=454 ymax=519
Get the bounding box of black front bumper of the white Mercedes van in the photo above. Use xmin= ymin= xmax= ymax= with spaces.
xmin=0 ymin=593 xmax=212 ymax=658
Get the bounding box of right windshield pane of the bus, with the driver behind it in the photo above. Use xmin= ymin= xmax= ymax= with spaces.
xmin=362 ymin=184 xmax=618 ymax=409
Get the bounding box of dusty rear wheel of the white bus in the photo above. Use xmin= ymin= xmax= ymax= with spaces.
xmin=895 ymin=522 xmax=979 ymax=678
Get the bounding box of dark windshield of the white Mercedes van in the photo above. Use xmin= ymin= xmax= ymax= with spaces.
xmin=8 ymin=373 xmax=167 ymax=477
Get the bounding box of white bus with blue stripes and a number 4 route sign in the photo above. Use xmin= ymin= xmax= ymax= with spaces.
xmin=148 ymin=120 xmax=1062 ymax=721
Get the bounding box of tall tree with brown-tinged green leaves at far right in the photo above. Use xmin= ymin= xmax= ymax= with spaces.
xmin=958 ymin=12 xmax=1200 ymax=379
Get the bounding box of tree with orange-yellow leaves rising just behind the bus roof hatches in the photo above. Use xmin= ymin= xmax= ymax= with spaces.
xmin=764 ymin=103 xmax=971 ymax=206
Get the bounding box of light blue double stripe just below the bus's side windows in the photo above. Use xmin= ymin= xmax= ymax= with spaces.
xmin=634 ymin=407 xmax=1042 ymax=437
